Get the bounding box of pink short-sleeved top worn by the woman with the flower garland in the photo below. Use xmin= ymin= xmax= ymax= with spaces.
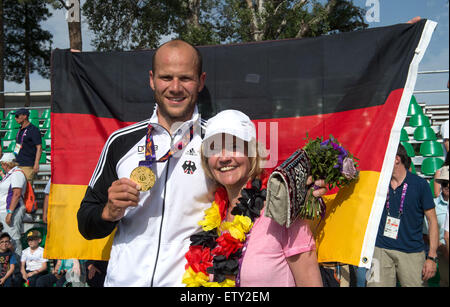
xmin=240 ymin=210 xmax=316 ymax=287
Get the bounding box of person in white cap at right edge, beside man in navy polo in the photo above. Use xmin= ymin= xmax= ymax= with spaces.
xmin=424 ymin=166 xmax=449 ymax=287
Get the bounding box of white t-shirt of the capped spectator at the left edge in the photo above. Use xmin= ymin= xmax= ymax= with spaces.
xmin=0 ymin=166 xmax=27 ymax=213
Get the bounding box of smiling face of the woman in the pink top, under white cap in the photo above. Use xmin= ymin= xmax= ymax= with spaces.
xmin=207 ymin=134 xmax=251 ymax=188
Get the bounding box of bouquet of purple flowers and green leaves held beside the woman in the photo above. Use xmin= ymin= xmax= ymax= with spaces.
xmin=300 ymin=135 xmax=359 ymax=219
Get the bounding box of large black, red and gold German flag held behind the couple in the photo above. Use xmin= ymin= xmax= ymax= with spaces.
xmin=45 ymin=20 xmax=436 ymax=267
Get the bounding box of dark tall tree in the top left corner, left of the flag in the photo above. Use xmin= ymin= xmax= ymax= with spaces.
xmin=3 ymin=0 xmax=52 ymax=106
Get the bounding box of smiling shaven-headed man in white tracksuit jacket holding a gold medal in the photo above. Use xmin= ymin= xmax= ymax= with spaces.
xmin=77 ymin=40 xmax=325 ymax=286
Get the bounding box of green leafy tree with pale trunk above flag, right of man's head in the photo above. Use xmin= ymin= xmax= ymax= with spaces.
xmin=217 ymin=0 xmax=368 ymax=42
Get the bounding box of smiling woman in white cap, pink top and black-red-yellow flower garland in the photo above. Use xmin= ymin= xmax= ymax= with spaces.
xmin=183 ymin=110 xmax=325 ymax=287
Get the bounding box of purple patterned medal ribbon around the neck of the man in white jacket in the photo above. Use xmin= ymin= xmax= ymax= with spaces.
xmin=139 ymin=124 xmax=194 ymax=167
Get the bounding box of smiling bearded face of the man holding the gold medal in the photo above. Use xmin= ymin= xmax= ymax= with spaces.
xmin=150 ymin=45 xmax=205 ymax=129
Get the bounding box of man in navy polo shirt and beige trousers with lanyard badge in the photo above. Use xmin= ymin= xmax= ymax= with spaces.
xmin=367 ymin=145 xmax=439 ymax=287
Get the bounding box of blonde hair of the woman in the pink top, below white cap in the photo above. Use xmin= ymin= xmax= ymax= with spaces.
xmin=200 ymin=141 xmax=267 ymax=182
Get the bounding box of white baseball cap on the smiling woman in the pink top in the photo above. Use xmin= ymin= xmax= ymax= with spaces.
xmin=204 ymin=110 xmax=256 ymax=142
